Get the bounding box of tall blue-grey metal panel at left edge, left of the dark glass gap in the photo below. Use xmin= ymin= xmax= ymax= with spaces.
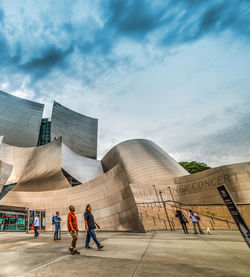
xmin=0 ymin=91 xmax=44 ymax=147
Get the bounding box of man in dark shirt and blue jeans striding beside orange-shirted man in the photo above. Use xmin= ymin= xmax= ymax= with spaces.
xmin=84 ymin=204 xmax=104 ymax=250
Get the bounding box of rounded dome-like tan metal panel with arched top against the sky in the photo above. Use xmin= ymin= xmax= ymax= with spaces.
xmin=102 ymin=139 xmax=189 ymax=187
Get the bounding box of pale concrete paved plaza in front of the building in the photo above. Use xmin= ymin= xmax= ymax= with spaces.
xmin=0 ymin=231 xmax=250 ymax=277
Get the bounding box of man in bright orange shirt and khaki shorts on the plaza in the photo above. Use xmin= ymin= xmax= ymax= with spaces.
xmin=67 ymin=205 xmax=80 ymax=255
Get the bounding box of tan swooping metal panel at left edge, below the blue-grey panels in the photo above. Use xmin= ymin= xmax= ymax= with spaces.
xmin=0 ymin=138 xmax=70 ymax=191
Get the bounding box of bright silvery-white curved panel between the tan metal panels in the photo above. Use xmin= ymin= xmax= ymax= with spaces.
xmin=62 ymin=144 xmax=103 ymax=184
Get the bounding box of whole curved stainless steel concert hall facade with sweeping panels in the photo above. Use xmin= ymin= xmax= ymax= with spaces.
xmin=0 ymin=89 xmax=250 ymax=232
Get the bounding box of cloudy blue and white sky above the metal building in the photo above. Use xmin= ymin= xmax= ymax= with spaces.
xmin=0 ymin=0 xmax=250 ymax=166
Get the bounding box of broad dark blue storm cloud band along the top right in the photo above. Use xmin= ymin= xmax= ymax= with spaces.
xmin=101 ymin=0 xmax=250 ymax=46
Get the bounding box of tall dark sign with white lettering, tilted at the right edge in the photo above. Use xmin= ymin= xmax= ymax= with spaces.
xmin=217 ymin=185 xmax=250 ymax=248
